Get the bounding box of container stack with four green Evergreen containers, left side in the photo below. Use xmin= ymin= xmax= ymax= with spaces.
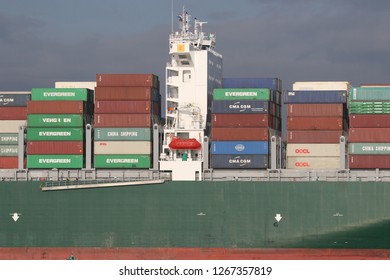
xmin=27 ymin=88 xmax=93 ymax=169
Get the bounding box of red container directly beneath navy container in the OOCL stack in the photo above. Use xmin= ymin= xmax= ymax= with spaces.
xmin=287 ymin=104 xmax=343 ymax=117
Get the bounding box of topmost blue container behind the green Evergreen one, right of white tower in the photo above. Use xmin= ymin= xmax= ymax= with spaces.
xmin=222 ymin=78 xmax=282 ymax=91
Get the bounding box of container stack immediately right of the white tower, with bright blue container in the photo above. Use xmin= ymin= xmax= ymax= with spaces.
xmin=211 ymin=78 xmax=281 ymax=169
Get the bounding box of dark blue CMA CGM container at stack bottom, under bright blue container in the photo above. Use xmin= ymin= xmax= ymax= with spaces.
xmin=211 ymin=154 xmax=268 ymax=169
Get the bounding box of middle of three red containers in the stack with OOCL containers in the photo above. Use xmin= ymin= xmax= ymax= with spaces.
xmin=287 ymin=117 xmax=343 ymax=130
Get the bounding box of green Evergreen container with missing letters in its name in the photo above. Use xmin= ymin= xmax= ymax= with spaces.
xmin=27 ymin=114 xmax=84 ymax=127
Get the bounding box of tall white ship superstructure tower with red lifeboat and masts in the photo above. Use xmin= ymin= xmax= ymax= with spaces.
xmin=160 ymin=8 xmax=222 ymax=180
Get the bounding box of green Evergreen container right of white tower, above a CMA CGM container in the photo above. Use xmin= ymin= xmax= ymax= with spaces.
xmin=213 ymin=88 xmax=274 ymax=101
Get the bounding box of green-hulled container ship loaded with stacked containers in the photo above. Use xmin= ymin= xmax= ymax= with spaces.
xmin=0 ymin=9 xmax=390 ymax=260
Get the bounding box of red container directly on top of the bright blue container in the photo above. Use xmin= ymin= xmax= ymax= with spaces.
xmin=211 ymin=127 xmax=268 ymax=141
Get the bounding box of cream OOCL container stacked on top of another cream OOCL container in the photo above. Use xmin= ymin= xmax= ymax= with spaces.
xmin=286 ymin=143 xmax=340 ymax=157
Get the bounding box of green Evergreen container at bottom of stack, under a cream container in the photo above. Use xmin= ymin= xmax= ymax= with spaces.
xmin=94 ymin=155 xmax=151 ymax=169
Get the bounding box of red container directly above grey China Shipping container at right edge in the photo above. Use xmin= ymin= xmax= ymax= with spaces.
xmin=348 ymin=128 xmax=390 ymax=143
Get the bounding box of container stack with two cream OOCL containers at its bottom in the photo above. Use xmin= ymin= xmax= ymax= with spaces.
xmin=285 ymin=82 xmax=350 ymax=169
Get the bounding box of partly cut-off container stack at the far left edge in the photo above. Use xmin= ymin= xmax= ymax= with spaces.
xmin=0 ymin=91 xmax=31 ymax=169
